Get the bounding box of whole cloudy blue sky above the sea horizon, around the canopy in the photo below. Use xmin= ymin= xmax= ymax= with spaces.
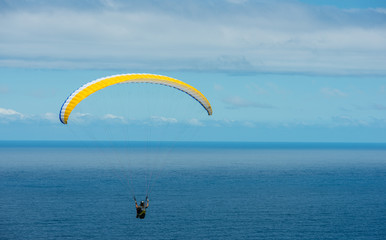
xmin=0 ymin=0 xmax=386 ymax=142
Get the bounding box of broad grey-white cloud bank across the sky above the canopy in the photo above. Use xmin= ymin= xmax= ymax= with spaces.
xmin=0 ymin=0 xmax=386 ymax=75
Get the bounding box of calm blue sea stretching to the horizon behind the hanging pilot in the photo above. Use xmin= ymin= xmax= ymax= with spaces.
xmin=0 ymin=142 xmax=386 ymax=239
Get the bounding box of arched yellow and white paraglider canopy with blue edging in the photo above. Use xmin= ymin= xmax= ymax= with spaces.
xmin=59 ymin=73 xmax=212 ymax=124
